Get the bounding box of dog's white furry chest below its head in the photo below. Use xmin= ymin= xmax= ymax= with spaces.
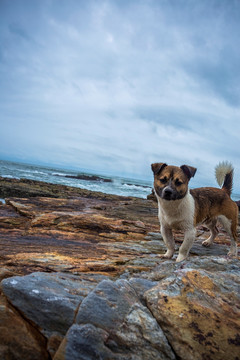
xmin=158 ymin=193 xmax=195 ymax=229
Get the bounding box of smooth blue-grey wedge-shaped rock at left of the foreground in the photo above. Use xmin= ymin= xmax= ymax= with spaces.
xmin=1 ymin=272 xmax=109 ymax=338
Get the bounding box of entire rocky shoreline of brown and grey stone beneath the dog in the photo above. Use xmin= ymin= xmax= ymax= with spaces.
xmin=0 ymin=178 xmax=240 ymax=360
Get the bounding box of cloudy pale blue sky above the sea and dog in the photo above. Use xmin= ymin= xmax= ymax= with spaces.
xmin=0 ymin=0 xmax=240 ymax=193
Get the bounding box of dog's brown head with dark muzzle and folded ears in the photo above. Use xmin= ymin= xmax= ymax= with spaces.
xmin=152 ymin=163 xmax=197 ymax=200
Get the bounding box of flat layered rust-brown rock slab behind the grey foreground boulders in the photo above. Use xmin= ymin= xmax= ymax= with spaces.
xmin=0 ymin=192 xmax=238 ymax=276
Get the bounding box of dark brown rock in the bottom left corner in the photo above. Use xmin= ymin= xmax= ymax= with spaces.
xmin=0 ymin=295 xmax=49 ymax=360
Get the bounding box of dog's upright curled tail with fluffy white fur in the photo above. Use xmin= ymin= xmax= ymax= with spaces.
xmin=215 ymin=161 xmax=233 ymax=196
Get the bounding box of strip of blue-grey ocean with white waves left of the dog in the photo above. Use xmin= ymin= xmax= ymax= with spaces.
xmin=0 ymin=160 xmax=152 ymax=198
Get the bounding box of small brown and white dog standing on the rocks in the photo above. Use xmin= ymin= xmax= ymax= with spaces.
xmin=152 ymin=162 xmax=238 ymax=262
